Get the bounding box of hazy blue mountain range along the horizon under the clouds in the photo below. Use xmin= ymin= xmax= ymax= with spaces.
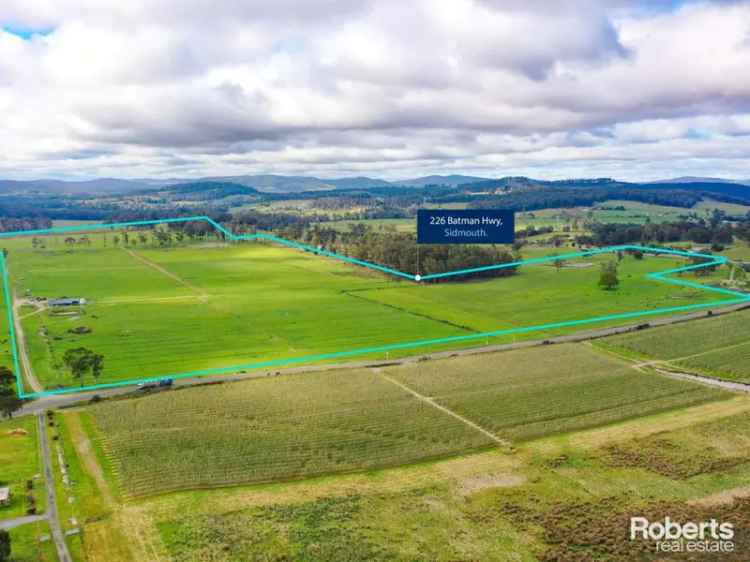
xmin=0 ymin=175 xmax=750 ymax=195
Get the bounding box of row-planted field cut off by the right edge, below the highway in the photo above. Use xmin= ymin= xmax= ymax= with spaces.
xmin=598 ymin=310 xmax=750 ymax=382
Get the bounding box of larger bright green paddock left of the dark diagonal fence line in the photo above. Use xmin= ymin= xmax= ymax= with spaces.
xmin=11 ymin=236 xmax=465 ymax=388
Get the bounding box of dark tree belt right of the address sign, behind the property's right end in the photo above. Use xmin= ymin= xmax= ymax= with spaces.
xmin=578 ymin=215 xmax=744 ymax=246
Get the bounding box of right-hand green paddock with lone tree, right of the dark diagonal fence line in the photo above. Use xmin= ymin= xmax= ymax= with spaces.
xmin=350 ymin=249 xmax=722 ymax=338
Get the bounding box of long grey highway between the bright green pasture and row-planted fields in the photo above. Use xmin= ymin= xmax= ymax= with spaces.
xmin=17 ymin=301 xmax=750 ymax=416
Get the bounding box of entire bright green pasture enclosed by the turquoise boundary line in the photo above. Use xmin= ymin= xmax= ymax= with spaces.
xmin=0 ymin=231 xmax=725 ymax=389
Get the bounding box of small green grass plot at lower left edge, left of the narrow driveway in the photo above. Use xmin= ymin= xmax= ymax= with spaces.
xmin=0 ymin=417 xmax=46 ymax=520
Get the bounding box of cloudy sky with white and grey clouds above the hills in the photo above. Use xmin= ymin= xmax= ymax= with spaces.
xmin=0 ymin=0 xmax=750 ymax=179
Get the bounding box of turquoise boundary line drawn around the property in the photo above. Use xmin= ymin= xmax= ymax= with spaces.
xmin=0 ymin=212 xmax=750 ymax=399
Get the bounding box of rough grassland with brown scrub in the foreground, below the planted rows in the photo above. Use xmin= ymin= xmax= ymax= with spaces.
xmin=66 ymin=376 xmax=750 ymax=562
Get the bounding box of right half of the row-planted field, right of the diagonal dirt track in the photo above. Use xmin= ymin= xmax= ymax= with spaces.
xmin=387 ymin=344 xmax=728 ymax=441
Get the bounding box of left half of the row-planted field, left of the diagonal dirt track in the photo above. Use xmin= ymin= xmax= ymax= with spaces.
xmin=91 ymin=371 xmax=494 ymax=496
